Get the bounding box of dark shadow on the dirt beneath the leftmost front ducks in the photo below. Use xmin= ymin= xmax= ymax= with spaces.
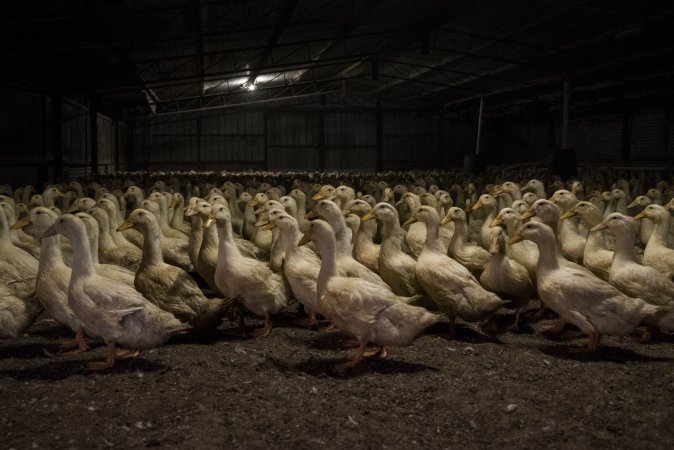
xmin=0 ymin=357 xmax=170 ymax=380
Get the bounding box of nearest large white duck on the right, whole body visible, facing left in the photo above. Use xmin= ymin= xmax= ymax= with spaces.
xmin=509 ymin=222 xmax=665 ymax=353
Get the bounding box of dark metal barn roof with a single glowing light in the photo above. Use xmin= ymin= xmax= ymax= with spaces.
xmin=0 ymin=0 xmax=674 ymax=114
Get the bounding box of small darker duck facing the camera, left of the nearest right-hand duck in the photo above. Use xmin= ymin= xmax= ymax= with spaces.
xmin=480 ymin=226 xmax=536 ymax=332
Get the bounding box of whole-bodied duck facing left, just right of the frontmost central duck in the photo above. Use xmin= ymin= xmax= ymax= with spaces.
xmin=409 ymin=206 xmax=507 ymax=337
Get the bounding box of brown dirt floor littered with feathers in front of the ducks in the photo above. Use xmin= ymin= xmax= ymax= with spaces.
xmin=0 ymin=306 xmax=674 ymax=449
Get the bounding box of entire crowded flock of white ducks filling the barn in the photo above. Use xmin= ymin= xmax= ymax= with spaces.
xmin=0 ymin=168 xmax=674 ymax=371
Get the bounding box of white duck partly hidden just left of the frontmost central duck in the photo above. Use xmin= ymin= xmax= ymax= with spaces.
xmin=267 ymin=210 xmax=322 ymax=327
